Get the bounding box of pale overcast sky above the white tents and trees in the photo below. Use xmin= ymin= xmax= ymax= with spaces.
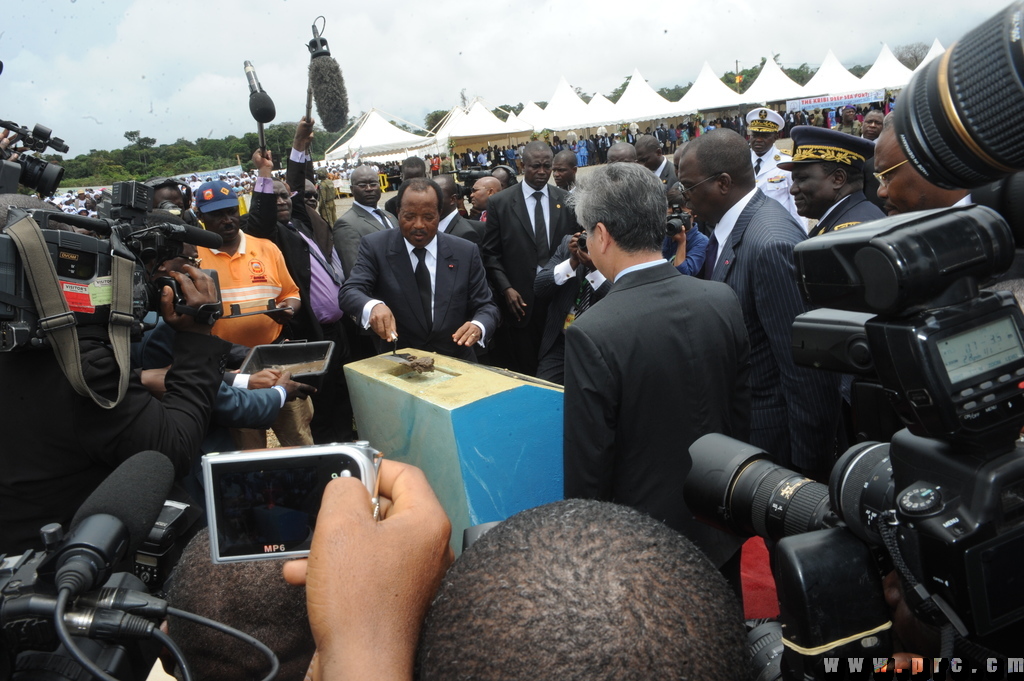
xmin=0 ymin=0 xmax=1007 ymax=157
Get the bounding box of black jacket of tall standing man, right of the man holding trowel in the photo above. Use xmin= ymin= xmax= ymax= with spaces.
xmin=481 ymin=184 xmax=580 ymax=328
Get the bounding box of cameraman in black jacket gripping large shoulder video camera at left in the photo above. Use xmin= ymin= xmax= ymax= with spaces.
xmin=0 ymin=202 xmax=229 ymax=553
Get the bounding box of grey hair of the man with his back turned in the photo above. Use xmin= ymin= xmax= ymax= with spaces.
xmin=568 ymin=163 xmax=669 ymax=253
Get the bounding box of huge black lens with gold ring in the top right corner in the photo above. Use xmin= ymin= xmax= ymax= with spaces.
xmin=896 ymin=3 xmax=1024 ymax=188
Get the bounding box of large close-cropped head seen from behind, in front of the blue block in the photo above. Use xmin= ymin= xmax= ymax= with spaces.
xmin=417 ymin=497 xmax=748 ymax=681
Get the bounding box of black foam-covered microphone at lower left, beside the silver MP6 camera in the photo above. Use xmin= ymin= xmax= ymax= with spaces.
xmin=39 ymin=452 xmax=174 ymax=596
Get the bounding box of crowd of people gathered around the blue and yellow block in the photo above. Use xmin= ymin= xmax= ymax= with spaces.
xmin=0 ymin=98 xmax=983 ymax=681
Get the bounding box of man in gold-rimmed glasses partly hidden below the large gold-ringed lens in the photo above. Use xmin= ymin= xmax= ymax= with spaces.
xmin=874 ymin=114 xmax=971 ymax=215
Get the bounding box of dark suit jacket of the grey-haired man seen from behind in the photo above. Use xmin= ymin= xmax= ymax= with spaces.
xmin=563 ymin=263 xmax=751 ymax=565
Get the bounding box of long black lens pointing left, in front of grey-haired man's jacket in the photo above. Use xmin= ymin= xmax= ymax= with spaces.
xmin=683 ymin=434 xmax=837 ymax=540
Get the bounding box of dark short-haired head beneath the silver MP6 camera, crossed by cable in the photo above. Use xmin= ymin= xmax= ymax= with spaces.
xmin=167 ymin=529 xmax=316 ymax=681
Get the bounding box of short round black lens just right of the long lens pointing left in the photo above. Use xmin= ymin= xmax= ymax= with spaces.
xmin=828 ymin=442 xmax=896 ymax=545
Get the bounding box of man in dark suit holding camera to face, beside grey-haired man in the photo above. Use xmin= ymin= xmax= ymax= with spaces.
xmin=534 ymin=233 xmax=611 ymax=383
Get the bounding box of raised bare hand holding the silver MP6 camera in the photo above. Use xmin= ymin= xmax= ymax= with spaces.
xmin=285 ymin=459 xmax=453 ymax=681
